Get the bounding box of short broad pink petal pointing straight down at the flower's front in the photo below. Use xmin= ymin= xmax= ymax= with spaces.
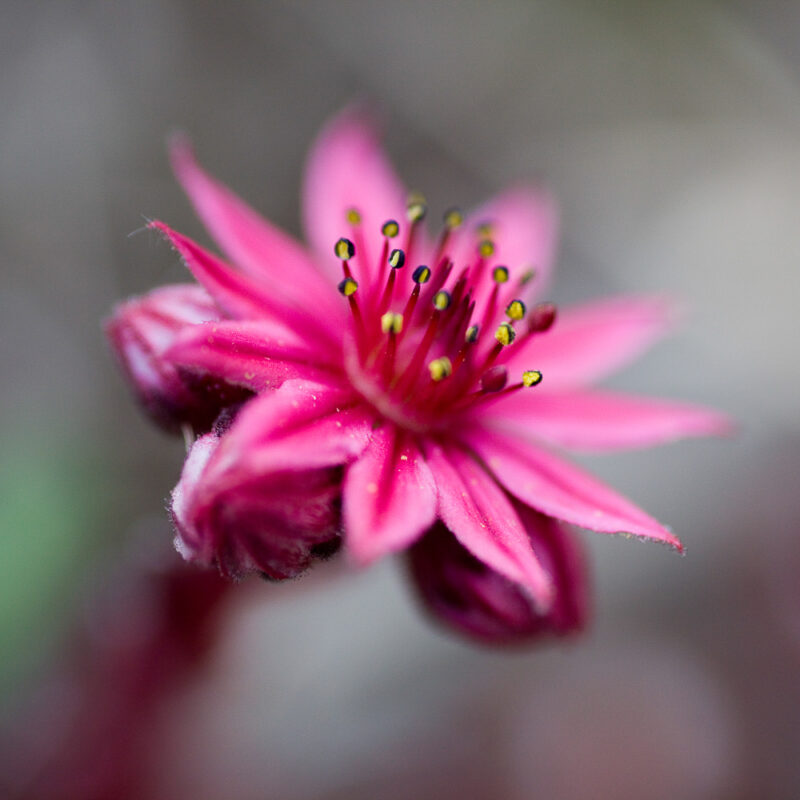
xmin=343 ymin=424 xmax=436 ymax=565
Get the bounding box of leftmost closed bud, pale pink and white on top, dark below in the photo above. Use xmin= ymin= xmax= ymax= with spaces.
xmin=105 ymin=285 xmax=250 ymax=433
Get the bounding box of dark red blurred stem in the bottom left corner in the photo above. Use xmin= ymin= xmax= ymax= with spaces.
xmin=0 ymin=553 xmax=233 ymax=800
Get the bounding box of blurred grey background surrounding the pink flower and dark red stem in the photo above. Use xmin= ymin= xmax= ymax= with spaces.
xmin=0 ymin=0 xmax=800 ymax=800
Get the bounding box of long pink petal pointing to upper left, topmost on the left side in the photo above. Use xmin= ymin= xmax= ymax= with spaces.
xmin=170 ymin=136 xmax=345 ymax=324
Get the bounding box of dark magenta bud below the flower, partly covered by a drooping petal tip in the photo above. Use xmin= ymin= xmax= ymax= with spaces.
xmin=409 ymin=506 xmax=588 ymax=644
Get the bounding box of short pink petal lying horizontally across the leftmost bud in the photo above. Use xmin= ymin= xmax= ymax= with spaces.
xmin=165 ymin=320 xmax=341 ymax=392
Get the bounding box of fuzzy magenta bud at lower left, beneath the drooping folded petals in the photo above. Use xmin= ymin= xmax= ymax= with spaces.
xmin=171 ymin=433 xmax=342 ymax=580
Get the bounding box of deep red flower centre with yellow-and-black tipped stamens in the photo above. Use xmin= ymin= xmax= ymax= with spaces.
xmin=334 ymin=196 xmax=555 ymax=432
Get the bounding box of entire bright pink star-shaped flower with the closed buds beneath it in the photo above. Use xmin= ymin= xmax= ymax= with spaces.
xmin=104 ymin=110 xmax=727 ymax=639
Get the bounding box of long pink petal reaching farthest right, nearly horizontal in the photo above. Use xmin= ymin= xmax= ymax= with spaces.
xmin=484 ymin=391 xmax=731 ymax=452
